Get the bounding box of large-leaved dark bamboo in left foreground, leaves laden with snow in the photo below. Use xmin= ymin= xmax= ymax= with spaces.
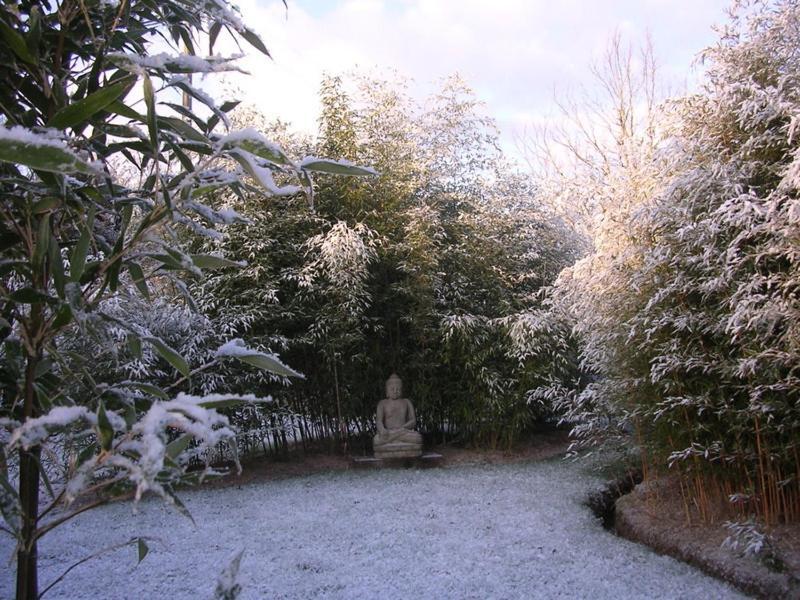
xmin=0 ymin=0 xmax=372 ymax=598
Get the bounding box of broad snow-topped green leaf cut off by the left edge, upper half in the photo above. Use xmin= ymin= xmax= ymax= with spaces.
xmin=0 ymin=126 xmax=98 ymax=175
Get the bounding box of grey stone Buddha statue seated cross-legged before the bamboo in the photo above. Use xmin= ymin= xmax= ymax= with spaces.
xmin=372 ymin=373 xmax=422 ymax=458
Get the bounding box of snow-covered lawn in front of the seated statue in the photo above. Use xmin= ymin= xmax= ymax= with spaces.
xmin=0 ymin=460 xmax=741 ymax=600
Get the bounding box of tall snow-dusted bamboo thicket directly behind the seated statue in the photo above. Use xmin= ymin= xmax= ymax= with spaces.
xmin=191 ymin=76 xmax=578 ymax=444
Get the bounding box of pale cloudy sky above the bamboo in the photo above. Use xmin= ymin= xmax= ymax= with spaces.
xmin=216 ymin=0 xmax=730 ymax=161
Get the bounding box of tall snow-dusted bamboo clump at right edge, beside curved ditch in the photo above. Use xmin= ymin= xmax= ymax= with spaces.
xmin=548 ymin=0 xmax=800 ymax=524
